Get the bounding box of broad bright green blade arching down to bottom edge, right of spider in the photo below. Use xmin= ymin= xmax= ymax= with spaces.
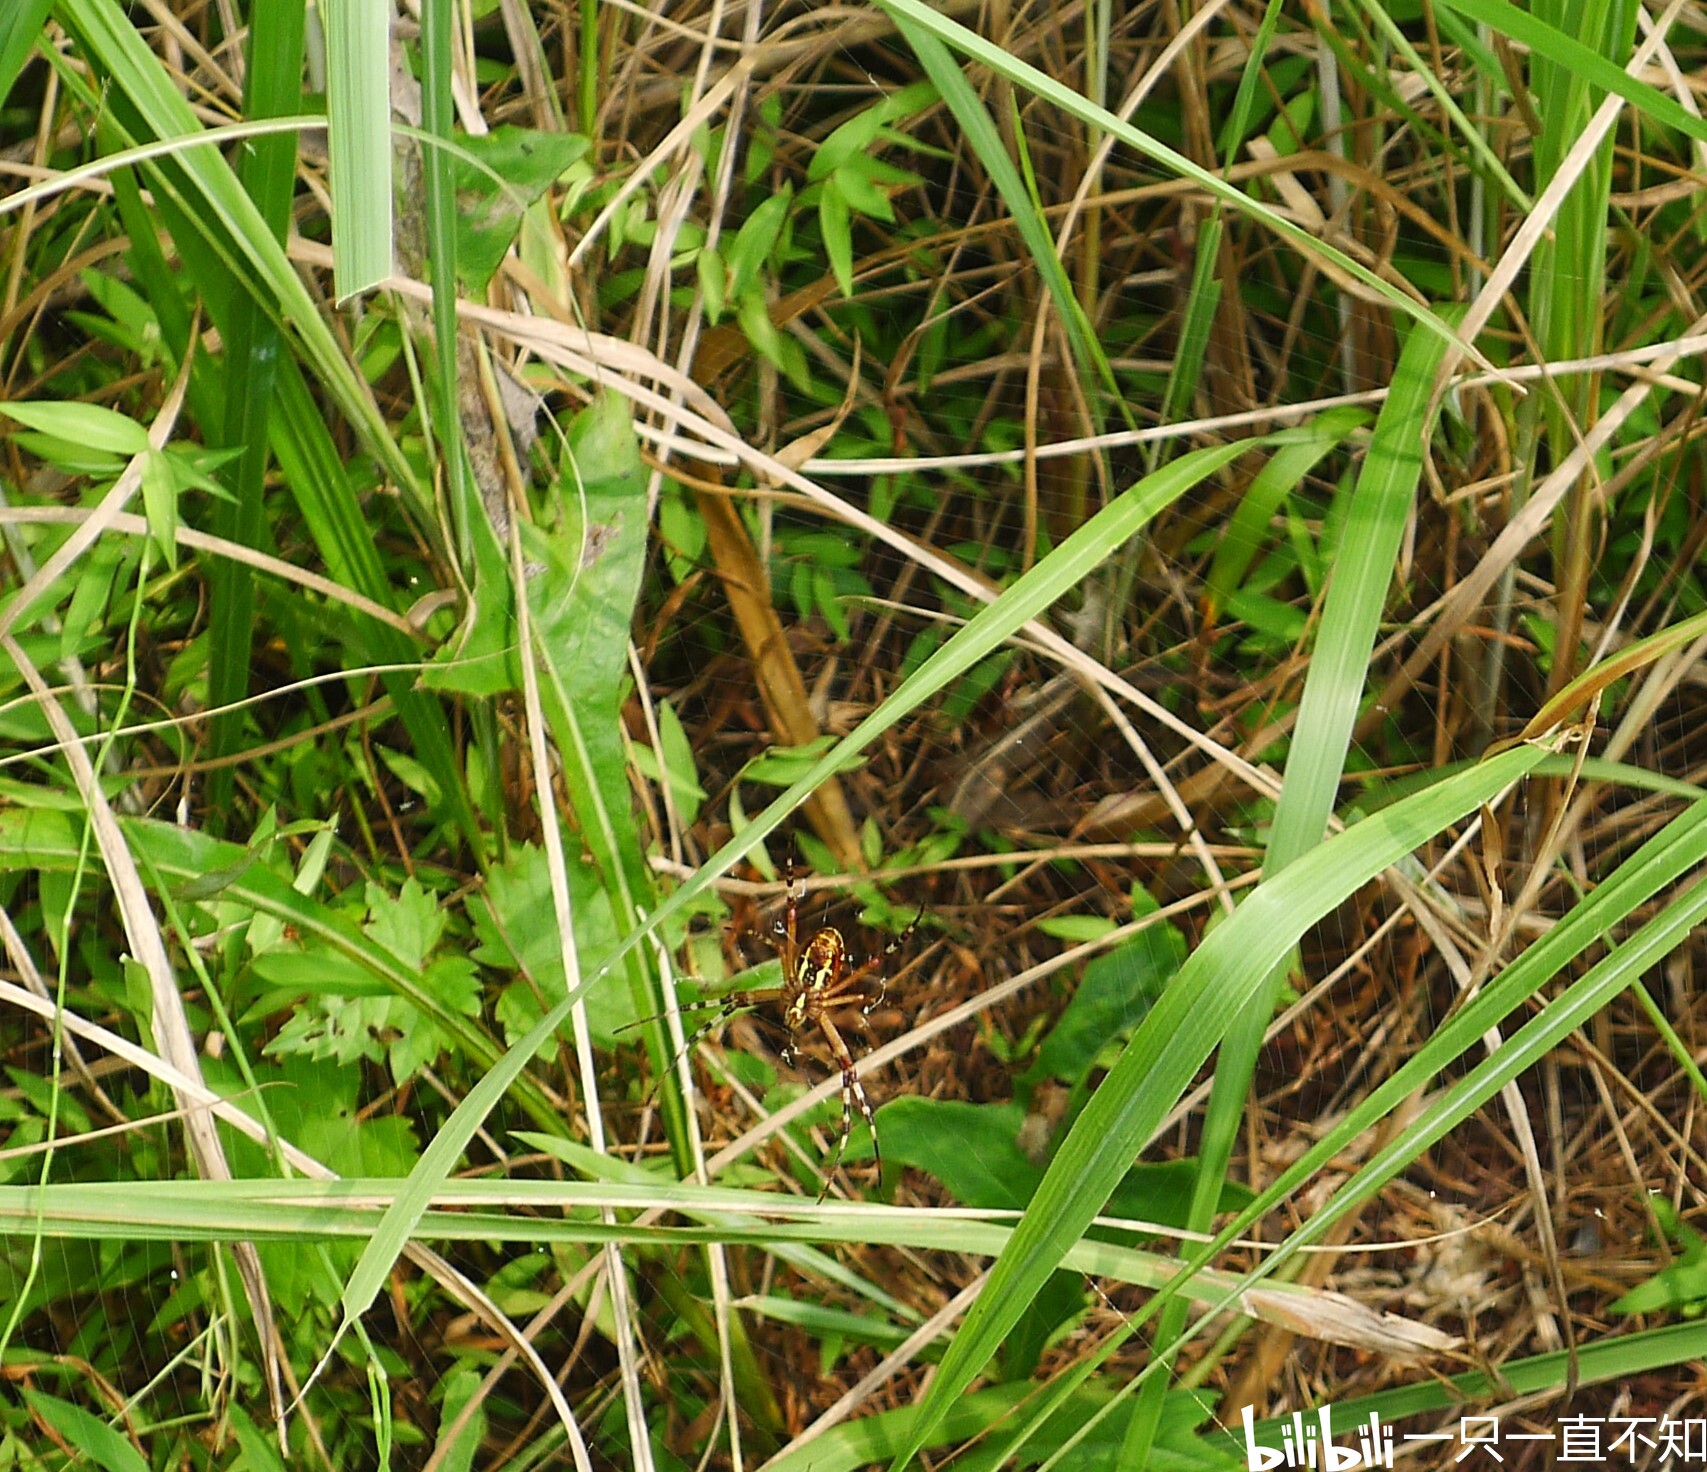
xmin=891 ymin=746 xmax=1545 ymax=1472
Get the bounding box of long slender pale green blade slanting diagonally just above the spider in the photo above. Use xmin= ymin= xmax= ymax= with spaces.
xmin=329 ymin=441 xmax=1261 ymax=1379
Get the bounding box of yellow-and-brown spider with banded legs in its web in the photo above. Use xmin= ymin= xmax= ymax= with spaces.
xmin=628 ymin=862 xmax=925 ymax=1200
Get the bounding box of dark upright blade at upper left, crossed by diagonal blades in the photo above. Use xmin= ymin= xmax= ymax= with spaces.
xmin=203 ymin=0 xmax=304 ymax=828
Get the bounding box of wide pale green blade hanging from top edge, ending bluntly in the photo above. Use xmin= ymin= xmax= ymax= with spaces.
xmin=319 ymin=0 xmax=391 ymax=302
